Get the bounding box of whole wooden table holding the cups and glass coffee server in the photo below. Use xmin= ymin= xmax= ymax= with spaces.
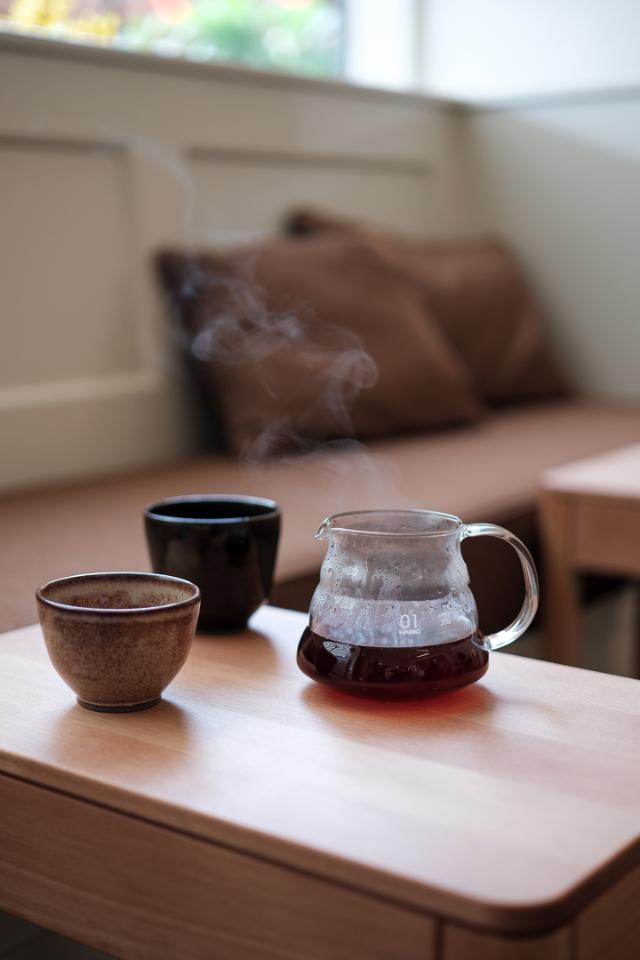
xmin=0 ymin=608 xmax=640 ymax=960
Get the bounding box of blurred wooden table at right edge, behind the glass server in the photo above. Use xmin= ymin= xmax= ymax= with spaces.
xmin=541 ymin=444 xmax=640 ymax=664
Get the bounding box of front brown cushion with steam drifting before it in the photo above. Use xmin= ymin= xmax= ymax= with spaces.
xmin=159 ymin=235 xmax=481 ymax=454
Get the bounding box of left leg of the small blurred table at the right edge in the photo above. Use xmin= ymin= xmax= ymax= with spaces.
xmin=541 ymin=491 xmax=579 ymax=666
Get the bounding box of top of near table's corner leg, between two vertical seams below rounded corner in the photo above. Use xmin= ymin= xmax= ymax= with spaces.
xmin=438 ymin=924 xmax=573 ymax=960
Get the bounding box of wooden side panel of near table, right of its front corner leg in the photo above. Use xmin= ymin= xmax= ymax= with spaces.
xmin=576 ymin=869 xmax=640 ymax=960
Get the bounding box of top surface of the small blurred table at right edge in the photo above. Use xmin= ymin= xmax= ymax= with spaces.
xmin=542 ymin=443 xmax=640 ymax=501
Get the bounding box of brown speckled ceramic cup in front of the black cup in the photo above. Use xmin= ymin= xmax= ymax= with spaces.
xmin=36 ymin=573 xmax=200 ymax=713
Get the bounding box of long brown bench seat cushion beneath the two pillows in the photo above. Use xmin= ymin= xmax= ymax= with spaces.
xmin=0 ymin=400 xmax=640 ymax=630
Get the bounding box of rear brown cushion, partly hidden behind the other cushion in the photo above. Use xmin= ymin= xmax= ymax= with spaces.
xmin=287 ymin=210 xmax=567 ymax=403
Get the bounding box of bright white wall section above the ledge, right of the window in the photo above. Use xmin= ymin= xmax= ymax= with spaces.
xmin=422 ymin=0 xmax=640 ymax=101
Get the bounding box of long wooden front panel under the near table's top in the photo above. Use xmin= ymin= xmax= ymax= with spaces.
xmin=0 ymin=775 xmax=434 ymax=960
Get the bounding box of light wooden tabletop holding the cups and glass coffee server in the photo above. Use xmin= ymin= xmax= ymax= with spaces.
xmin=0 ymin=607 xmax=640 ymax=931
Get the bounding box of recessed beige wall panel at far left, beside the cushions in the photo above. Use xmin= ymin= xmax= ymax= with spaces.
xmin=0 ymin=137 xmax=140 ymax=386
